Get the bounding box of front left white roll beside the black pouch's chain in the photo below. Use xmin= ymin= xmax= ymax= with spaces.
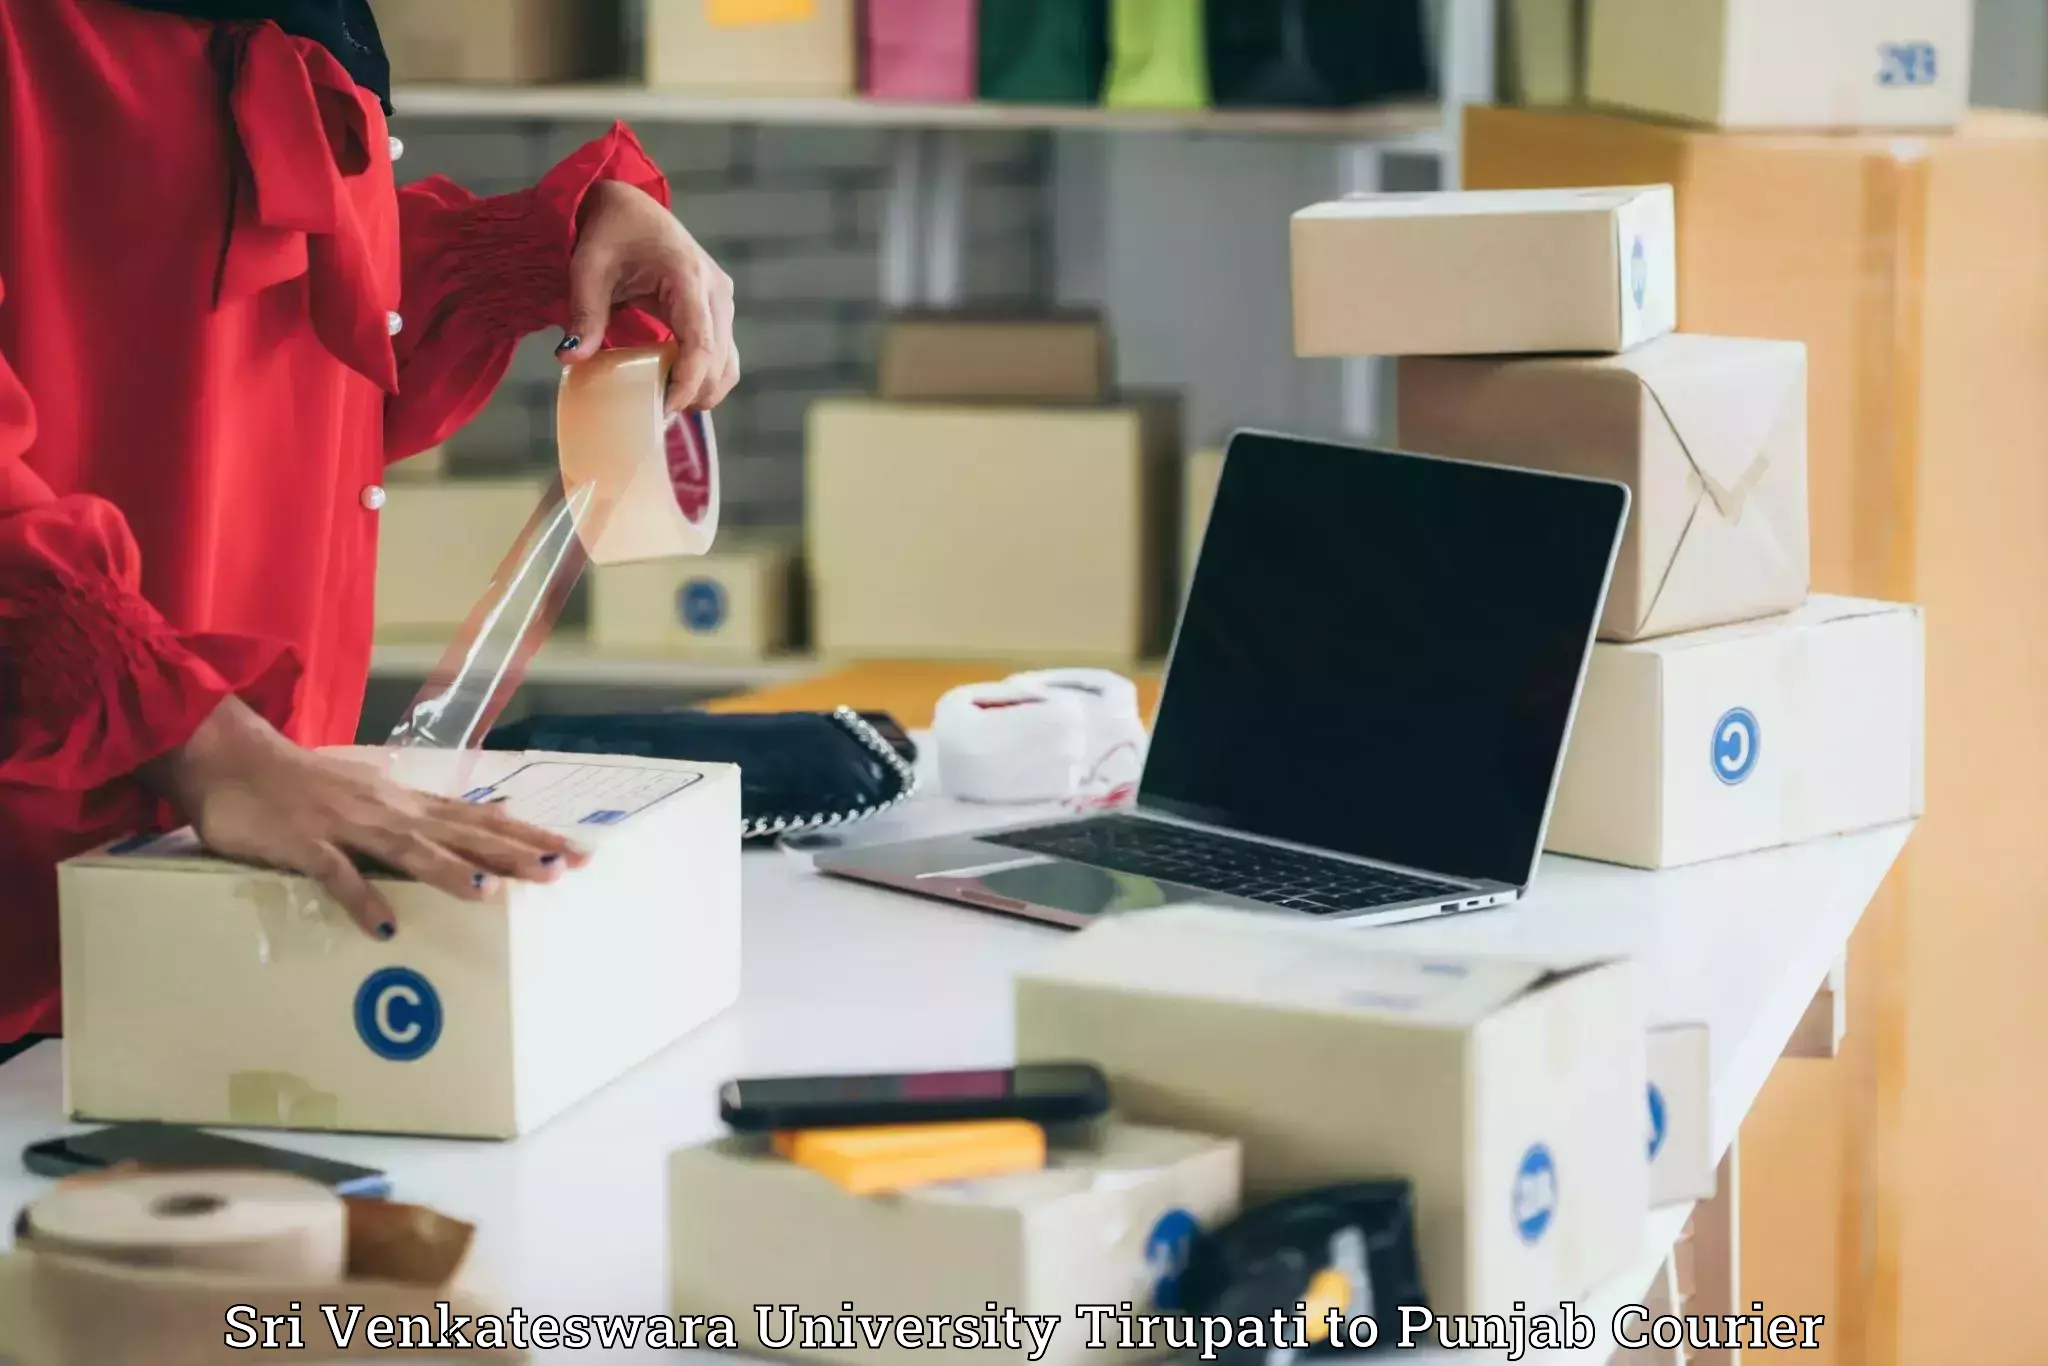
xmin=932 ymin=682 xmax=1087 ymax=805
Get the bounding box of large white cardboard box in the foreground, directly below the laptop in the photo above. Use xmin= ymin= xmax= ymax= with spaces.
xmin=1016 ymin=909 xmax=1649 ymax=1313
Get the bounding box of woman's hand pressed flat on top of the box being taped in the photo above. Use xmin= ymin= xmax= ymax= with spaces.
xmin=143 ymin=698 xmax=588 ymax=940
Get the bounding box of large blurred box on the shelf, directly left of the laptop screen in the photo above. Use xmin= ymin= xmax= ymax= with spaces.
xmin=805 ymin=399 xmax=1180 ymax=666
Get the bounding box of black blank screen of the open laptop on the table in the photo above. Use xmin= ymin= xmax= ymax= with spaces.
xmin=1139 ymin=434 xmax=1628 ymax=885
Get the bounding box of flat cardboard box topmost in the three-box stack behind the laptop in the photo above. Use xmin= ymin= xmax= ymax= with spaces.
xmin=1292 ymin=184 xmax=1677 ymax=356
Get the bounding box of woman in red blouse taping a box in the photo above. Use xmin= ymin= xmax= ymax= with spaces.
xmin=0 ymin=0 xmax=739 ymax=1055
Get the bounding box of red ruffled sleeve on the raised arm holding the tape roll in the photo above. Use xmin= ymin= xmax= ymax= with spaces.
xmin=385 ymin=123 xmax=668 ymax=461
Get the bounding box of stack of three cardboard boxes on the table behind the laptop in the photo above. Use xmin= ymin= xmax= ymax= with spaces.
xmin=1294 ymin=186 xmax=1921 ymax=868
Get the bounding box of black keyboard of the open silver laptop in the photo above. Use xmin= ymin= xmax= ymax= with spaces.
xmin=979 ymin=815 xmax=1468 ymax=915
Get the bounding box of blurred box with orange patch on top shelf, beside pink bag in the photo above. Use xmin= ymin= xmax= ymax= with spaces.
xmin=645 ymin=0 xmax=860 ymax=96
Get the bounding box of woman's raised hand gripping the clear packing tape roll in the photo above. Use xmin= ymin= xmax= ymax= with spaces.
xmin=555 ymin=180 xmax=739 ymax=412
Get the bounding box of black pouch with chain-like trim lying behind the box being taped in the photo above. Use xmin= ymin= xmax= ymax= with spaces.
xmin=483 ymin=707 xmax=918 ymax=840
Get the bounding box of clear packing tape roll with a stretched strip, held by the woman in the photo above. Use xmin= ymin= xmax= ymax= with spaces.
xmin=385 ymin=344 xmax=719 ymax=750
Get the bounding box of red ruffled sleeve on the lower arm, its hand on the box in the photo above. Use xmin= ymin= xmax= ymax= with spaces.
xmin=0 ymin=278 xmax=299 ymax=811
